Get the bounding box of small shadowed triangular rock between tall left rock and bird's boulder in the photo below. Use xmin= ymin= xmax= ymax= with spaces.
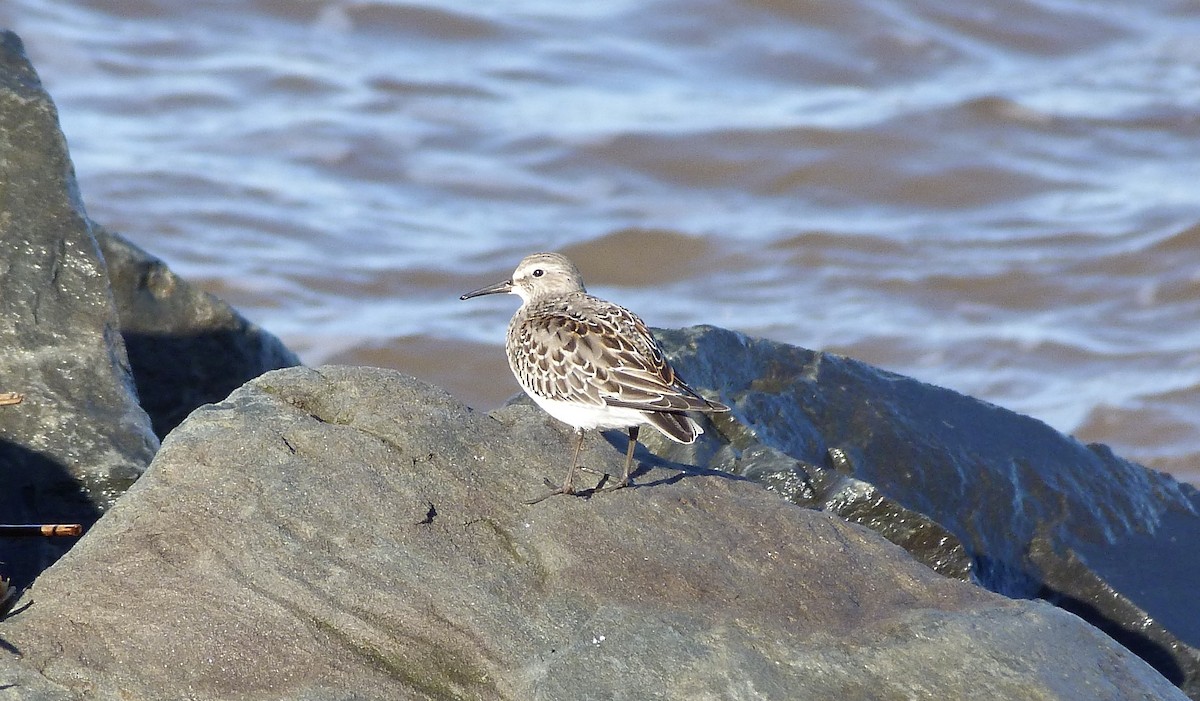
xmin=95 ymin=227 xmax=300 ymax=438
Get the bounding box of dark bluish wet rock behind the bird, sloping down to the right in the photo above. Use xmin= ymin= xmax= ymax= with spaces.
xmin=649 ymin=326 xmax=1200 ymax=699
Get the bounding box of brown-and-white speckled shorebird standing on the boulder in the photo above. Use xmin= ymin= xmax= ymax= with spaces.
xmin=460 ymin=253 xmax=730 ymax=504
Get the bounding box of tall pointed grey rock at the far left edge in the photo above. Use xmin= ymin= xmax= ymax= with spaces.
xmin=0 ymin=32 xmax=158 ymax=586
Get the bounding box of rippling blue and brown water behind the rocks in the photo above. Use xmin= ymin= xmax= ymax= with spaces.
xmin=0 ymin=0 xmax=1200 ymax=481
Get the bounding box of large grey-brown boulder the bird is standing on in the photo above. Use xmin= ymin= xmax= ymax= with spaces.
xmin=0 ymin=367 xmax=1183 ymax=700
